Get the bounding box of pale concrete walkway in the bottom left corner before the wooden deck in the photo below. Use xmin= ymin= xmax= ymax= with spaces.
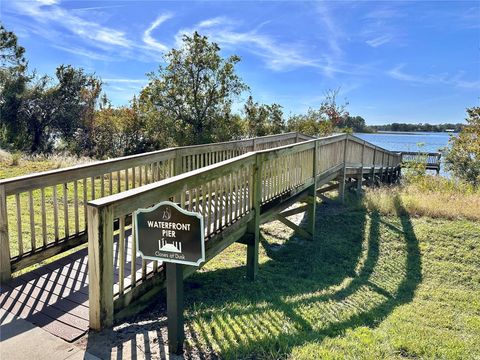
xmin=0 ymin=309 xmax=99 ymax=360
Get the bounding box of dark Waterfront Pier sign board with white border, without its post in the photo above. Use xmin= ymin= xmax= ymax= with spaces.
xmin=134 ymin=201 xmax=205 ymax=266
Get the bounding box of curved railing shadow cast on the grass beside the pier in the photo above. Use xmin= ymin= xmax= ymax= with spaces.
xmin=182 ymin=198 xmax=421 ymax=358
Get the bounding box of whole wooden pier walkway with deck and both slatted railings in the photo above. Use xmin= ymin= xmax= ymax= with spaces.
xmin=0 ymin=133 xmax=402 ymax=341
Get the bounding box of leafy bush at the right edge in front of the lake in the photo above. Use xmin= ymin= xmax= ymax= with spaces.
xmin=445 ymin=107 xmax=480 ymax=187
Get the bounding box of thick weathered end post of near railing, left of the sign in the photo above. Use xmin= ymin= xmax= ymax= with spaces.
xmin=87 ymin=205 xmax=113 ymax=331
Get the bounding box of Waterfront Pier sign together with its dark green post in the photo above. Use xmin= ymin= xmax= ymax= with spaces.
xmin=134 ymin=201 xmax=205 ymax=354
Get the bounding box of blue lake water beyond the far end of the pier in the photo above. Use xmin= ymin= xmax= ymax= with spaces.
xmin=354 ymin=132 xmax=455 ymax=177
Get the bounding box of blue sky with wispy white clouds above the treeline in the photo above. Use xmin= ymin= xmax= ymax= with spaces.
xmin=1 ymin=0 xmax=480 ymax=124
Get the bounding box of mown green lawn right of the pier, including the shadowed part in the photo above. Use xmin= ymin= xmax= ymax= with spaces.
xmin=176 ymin=197 xmax=480 ymax=359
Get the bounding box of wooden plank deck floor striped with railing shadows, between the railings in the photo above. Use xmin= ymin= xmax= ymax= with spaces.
xmin=0 ymin=191 xmax=251 ymax=342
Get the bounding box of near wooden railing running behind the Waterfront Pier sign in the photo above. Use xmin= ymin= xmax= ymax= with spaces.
xmin=87 ymin=135 xmax=401 ymax=329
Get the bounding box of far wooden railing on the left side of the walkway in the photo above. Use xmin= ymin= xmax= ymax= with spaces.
xmin=0 ymin=133 xmax=310 ymax=280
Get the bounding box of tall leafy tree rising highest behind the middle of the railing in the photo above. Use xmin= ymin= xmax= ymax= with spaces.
xmin=140 ymin=32 xmax=247 ymax=145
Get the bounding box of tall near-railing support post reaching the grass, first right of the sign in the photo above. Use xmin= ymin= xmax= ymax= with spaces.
xmin=247 ymin=154 xmax=263 ymax=281
